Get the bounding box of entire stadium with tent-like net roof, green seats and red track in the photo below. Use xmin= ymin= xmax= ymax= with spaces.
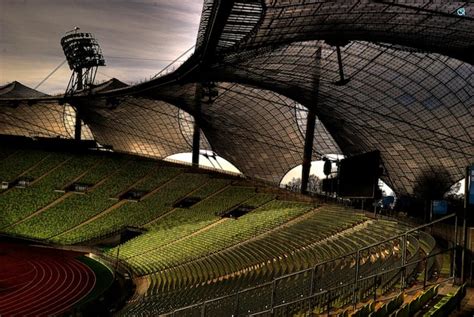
xmin=0 ymin=0 xmax=474 ymax=317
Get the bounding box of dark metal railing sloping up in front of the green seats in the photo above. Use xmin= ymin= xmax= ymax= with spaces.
xmin=150 ymin=214 xmax=458 ymax=316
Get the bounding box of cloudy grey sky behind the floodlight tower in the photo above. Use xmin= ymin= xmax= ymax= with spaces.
xmin=0 ymin=0 xmax=203 ymax=94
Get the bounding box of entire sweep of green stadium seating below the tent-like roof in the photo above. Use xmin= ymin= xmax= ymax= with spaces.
xmin=0 ymin=150 xmax=446 ymax=316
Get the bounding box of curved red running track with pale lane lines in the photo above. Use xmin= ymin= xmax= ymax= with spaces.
xmin=0 ymin=243 xmax=96 ymax=317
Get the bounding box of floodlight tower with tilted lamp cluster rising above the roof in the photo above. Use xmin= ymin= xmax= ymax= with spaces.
xmin=61 ymin=27 xmax=105 ymax=140
